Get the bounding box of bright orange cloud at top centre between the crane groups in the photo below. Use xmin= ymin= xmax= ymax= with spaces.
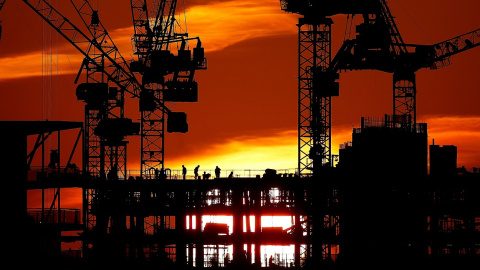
xmin=186 ymin=0 xmax=297 ymax=51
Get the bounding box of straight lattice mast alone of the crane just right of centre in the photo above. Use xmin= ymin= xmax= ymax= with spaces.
xmin=298 ymin=17 xmax=338 ymax=175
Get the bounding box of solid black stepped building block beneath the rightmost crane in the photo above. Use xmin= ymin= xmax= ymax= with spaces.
xmin=337 ymin=115 xmax=480 ymax=266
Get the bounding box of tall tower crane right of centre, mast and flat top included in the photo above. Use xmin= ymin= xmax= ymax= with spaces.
xmin=280 ymin=0 xmax=378 ymax=176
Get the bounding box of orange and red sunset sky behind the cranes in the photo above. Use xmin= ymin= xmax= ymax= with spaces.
xmin=0 ymin=0 xmax=480 ymax=179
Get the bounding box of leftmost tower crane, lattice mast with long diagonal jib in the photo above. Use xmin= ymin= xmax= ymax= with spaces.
xmin=24 ymin=0 xmax=140 ymax=177
